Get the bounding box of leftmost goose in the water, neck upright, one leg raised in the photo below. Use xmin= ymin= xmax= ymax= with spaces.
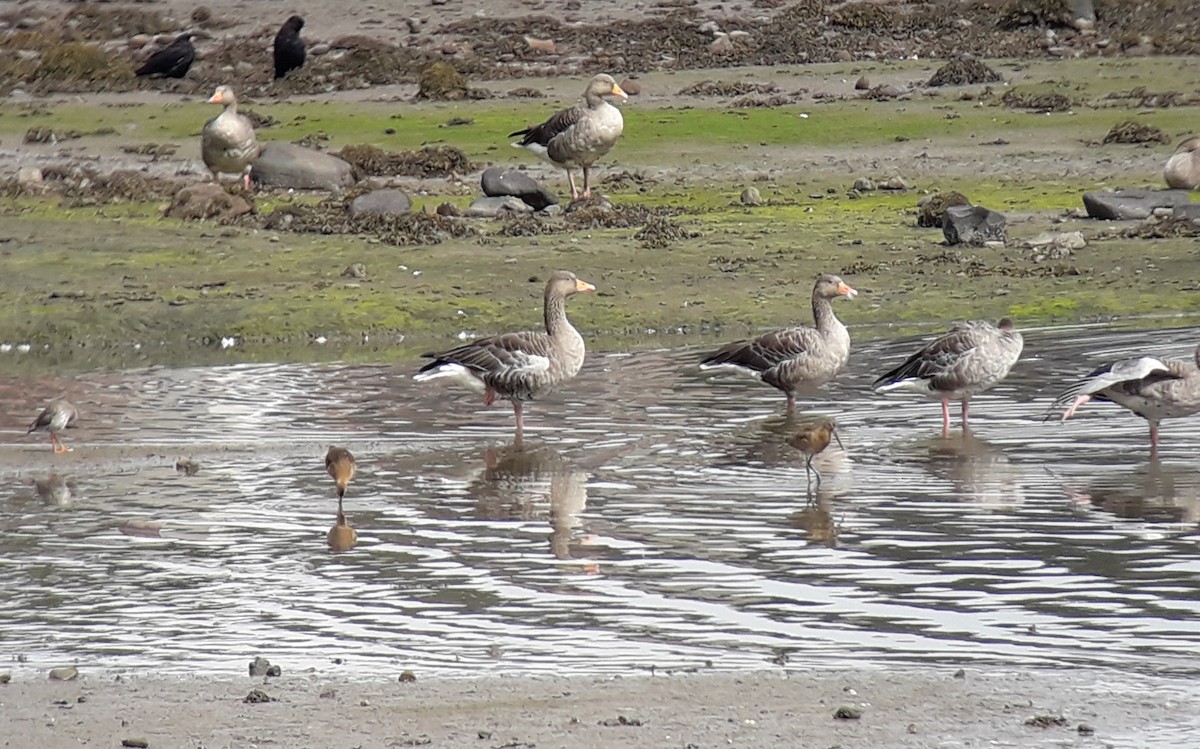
xmin=413 ymin=270 xmax=595 ymax=445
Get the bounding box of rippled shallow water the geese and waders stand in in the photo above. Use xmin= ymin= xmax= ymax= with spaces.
xmin=0 ymin=328 xmax=1200 ymax=675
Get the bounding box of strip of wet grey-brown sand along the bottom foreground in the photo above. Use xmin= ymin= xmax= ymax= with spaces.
xmin=9 ymin=665 xmax=1200 ymax=749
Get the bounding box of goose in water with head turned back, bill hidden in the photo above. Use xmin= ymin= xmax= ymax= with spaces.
xmin=871 ymin=317 xmax=1025 ymax=437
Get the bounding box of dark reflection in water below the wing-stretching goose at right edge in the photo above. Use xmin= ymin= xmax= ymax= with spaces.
xmin=1063 ymin=460 xmax=1200 ymax=523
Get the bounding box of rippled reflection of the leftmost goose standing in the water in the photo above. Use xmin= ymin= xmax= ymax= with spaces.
xmin=468 ymin=447 xmax=599 ymax=573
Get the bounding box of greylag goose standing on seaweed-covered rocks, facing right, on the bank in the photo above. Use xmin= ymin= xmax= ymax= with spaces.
xmin=509 ymin=73 xmax=629 ymax=200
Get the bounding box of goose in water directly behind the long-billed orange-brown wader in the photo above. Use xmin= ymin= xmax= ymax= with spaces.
xmin=700 ymin=275 xmax=858 ymax=414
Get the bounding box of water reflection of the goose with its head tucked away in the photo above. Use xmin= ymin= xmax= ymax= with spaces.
xmin=926 ymin=433 xmax=1025 ymax=504
